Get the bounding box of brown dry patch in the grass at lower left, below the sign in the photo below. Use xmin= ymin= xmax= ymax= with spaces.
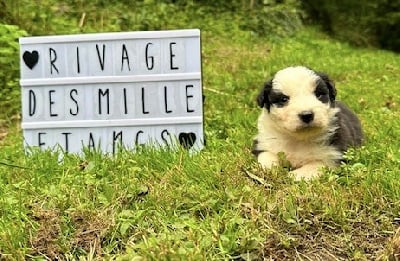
xmin=29 ymin=206 xmax=111 ymax=260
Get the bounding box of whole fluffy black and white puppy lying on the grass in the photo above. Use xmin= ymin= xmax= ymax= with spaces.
xmin=253 ymin=66 xmax=363 ymax=179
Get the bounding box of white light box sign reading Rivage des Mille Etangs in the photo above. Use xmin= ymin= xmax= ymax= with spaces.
xmin=19 ymin=29 xmax=204 ymax=153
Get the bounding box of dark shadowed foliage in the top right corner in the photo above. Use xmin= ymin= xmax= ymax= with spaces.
xmin=301 ymin=0 xmax=400 ymax=52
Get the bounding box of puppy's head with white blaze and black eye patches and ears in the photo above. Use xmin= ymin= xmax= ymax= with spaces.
xmin=257 ymin=66 xmax=337 ymax=138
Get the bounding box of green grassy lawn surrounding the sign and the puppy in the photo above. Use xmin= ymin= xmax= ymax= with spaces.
xmin=0 ymin=5 xmax=400 ymax=260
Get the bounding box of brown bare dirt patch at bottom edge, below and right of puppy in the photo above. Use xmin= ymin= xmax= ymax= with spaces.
xmin=262 ymin=221 xmax=392 ymax=260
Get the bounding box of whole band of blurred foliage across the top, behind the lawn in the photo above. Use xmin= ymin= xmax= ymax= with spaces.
xmin=0 ymin=0 xmax=400 ymax=119
